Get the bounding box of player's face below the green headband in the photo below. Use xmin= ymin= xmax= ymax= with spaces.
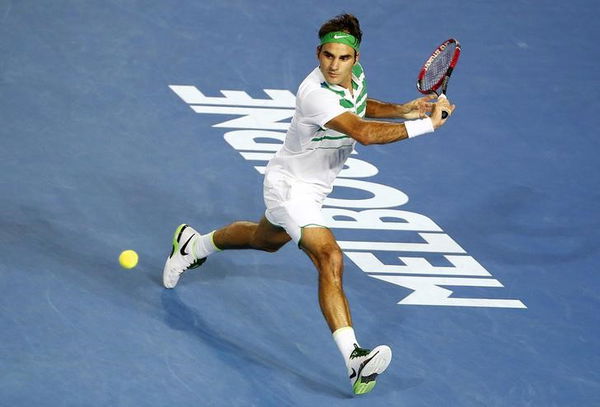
xmin=317 ymin=42 xmax=358 ymax=88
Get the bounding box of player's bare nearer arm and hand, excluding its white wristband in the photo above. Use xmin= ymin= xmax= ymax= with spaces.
xmin=326 ymin=99 xmax=454 ymax=145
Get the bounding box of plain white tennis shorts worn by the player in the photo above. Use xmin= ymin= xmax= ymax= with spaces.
xmin=263 ymin=171 xmax=327 ymax=244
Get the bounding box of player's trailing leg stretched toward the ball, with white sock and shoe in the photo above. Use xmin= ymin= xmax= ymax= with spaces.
xmin=163 ymin=217 xmax=290 ymax=288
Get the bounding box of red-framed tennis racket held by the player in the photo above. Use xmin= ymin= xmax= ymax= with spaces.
xmin=417 ymin=38 xmax=460 ymax=119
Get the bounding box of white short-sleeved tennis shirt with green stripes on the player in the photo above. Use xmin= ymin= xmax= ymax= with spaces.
xmin=265 ymin=63 xmax=367 ymax=199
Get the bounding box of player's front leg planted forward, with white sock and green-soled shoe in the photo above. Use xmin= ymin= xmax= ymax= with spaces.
xmin=300 ymin=227 xmax=392 ymax=394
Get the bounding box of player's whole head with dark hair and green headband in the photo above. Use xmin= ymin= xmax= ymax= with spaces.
xmin=317 ymin=14 xmax=362 ymax=88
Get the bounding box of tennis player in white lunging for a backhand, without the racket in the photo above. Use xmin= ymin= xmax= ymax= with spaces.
xmin=163 ymin=14 xmax=454 ymax=394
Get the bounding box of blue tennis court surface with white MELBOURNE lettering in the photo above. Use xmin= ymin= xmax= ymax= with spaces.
xmin=0 ymin=0 xmax=600 ymax=407
